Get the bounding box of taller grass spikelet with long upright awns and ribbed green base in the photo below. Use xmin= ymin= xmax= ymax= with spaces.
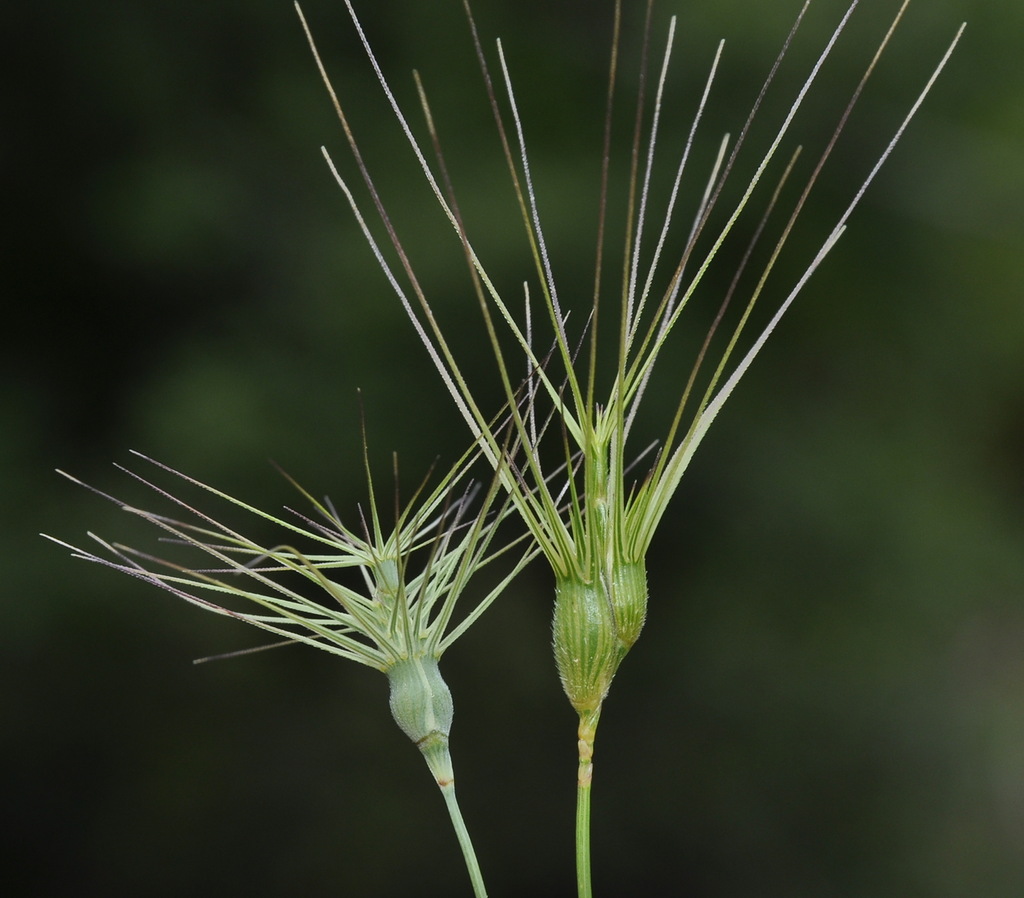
xmin=300 ymin=0 xmax=963 ymax=896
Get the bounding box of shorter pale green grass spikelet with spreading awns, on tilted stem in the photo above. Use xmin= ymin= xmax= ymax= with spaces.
xmin=48 ymin=442 xmax=535 ymax=896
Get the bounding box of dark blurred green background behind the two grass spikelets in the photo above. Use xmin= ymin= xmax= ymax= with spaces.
xmin=0 ymin=0 xmax=1024 ymax=898
